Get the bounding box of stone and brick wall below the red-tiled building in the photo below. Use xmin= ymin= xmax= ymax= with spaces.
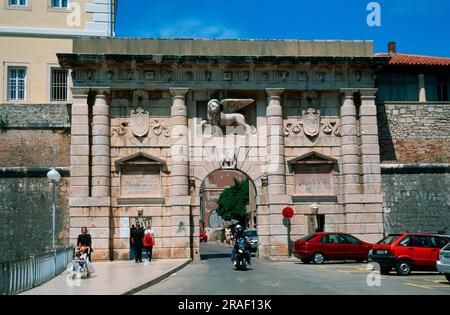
xmin=378 ymin=103 xmax=450 ymax=237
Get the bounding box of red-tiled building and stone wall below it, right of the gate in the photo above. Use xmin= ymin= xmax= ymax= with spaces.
xmin=376 ymin=43 xmax=450 ymax=234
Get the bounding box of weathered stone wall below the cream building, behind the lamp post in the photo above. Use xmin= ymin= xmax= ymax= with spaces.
xmin=0 ymin=104 xmax=70 ymax=262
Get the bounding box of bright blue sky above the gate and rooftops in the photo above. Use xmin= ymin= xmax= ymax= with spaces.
xmin=117 ymin=0 xmax=450 ymax=56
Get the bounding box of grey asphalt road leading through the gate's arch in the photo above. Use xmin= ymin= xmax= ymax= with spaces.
xmin=138 ymin=245 xmax=450 ymax=296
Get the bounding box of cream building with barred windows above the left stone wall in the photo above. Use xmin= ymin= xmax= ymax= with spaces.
xmin=0 ymin=0 xmax=116 ymax=104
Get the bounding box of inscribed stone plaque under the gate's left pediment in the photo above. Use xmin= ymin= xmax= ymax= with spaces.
xmin=121 ymin=166 xmax=161 ymax=197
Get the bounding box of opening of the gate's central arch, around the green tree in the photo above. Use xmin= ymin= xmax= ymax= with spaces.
xmin=199 ymin=170 xmax=258 ymax=259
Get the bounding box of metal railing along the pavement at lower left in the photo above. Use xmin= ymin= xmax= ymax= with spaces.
xmin=0 ymin=247 xmax=74 ymax=295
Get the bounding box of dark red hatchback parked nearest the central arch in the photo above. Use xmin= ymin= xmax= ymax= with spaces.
xmin=294 ymin=233 xmax=373 ymax=264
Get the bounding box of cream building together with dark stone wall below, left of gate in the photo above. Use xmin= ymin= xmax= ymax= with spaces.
xmin=0 ymin=0 xmax=117 ymax=261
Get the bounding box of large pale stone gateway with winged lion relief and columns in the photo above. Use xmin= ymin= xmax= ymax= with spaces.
xmin=59 ymin=39 xmax=383 ymax=260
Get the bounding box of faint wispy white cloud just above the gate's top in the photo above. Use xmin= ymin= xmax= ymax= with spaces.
xmin=147 ymin=19 xmax=240 ymax=39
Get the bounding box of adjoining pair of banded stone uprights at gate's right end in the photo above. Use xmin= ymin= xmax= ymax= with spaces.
xmin=341 ymin=89 xmax=383 ymax=242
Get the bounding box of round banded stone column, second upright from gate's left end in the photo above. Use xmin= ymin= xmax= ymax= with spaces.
xmin=92 ymin=91 xmax=111 ymax=198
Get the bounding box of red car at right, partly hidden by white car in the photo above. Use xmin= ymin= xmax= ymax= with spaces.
xmin=369 ymin=233 xmax=449 ymax=276
